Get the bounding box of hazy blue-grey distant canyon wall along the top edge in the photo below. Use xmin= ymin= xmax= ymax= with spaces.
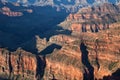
xmin=5 ymin=0 xmax=120 ymax=12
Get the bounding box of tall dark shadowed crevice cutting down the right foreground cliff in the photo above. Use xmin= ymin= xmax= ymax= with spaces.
xmin=80 ymin=42 xmax=94 ymax=80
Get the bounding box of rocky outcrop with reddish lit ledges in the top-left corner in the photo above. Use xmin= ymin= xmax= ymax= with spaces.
xmin=0 ymin=1 xmax=33 ymax=17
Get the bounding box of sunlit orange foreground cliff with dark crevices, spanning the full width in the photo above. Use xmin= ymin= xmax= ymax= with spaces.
xmin=0 ymin=23 xmax=120 ymax=80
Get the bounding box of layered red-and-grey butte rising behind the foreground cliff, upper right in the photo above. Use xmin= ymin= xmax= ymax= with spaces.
xmin=60 ymin=3 xmax=120 ymax=33
